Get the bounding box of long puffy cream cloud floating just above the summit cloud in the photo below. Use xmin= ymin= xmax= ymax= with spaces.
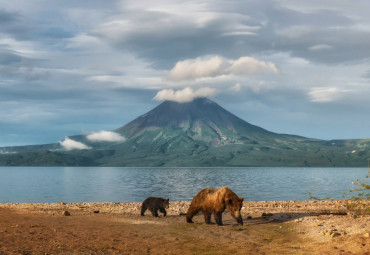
xmin=167 ymin=56 xmax=279 ymax=81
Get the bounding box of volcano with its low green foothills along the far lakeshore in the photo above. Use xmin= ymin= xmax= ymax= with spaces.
xmin=0 ymin=98 xmax=370 ymax=167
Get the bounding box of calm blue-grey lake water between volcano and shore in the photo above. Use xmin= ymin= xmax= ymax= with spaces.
xmin=0 ymin=167 xmax=368 ymax=203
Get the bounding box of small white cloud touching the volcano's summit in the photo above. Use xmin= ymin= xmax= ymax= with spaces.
xmin=153 ymin=87 xmax=216 ymax=103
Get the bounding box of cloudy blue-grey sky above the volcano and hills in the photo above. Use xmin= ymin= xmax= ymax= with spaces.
xmin=0 ymin=0 xmax=370 ymax=147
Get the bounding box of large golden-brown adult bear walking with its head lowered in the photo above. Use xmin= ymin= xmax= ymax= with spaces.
xmin=186 ymin=187 xmax=244 ymax=226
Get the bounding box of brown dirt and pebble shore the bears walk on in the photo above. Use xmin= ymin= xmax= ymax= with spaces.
xmin=0 ymin=201 xmax=370 ymax=254
